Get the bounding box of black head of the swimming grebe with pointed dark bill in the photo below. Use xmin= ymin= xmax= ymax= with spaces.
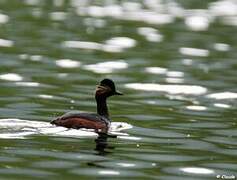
xmin=96 ymin=79 xmax=123 ymax=97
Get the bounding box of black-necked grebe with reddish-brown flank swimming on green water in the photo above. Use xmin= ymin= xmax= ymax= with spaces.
xmin=51 ymin=79 xmax=122 ymax=133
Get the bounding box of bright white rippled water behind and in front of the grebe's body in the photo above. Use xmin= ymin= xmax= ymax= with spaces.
xmin=0 ymin=119 xmax=132 ymax=139
